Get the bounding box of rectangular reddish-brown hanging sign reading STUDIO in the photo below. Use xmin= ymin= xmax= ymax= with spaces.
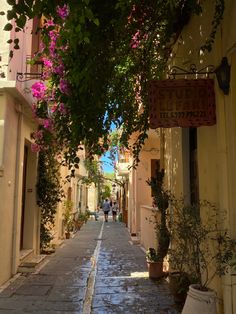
xmin=149 ymin=79 xmax=216 ymax=129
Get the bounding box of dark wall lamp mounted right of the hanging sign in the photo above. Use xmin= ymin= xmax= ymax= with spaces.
xmin=214 ymin=57 xmax=230 ymax=95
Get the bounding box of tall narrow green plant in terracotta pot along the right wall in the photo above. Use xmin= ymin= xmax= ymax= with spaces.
xmin=146 ymin=169 xmax=170 ymax=278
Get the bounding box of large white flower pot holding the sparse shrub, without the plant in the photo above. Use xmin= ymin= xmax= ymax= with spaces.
xmin=182 ymin=285 xmax=217 ymax=314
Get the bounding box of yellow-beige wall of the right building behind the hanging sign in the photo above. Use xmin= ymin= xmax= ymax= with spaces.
xmin=163 ymin=0 xmax=236 ymax=314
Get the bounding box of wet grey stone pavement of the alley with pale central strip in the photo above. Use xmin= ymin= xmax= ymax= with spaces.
xmin=0 ymin=217 xmax=182 ymax=314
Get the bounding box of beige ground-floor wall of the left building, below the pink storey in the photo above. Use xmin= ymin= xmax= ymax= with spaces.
xmin=0 ymin=92 xmax=39 ymax=283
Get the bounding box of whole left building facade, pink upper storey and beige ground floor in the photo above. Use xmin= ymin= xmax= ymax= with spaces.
xmin=0 ymin=1 xmax=40 ymax=284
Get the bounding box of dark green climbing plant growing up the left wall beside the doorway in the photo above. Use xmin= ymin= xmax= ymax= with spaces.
xmin=37 ymin=151 xmax=63 ymax=251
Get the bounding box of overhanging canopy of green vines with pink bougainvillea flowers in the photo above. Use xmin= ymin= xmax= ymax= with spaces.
xmin=5 ymin=0 xmax=224 ymax=165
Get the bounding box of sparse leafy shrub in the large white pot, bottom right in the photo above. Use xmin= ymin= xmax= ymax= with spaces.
xmin=170 ymin=201 xmax=235 ymax=314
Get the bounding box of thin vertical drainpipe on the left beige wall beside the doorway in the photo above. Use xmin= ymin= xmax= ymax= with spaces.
xmin=12 ymin=104 xmax=23 ymax=275
